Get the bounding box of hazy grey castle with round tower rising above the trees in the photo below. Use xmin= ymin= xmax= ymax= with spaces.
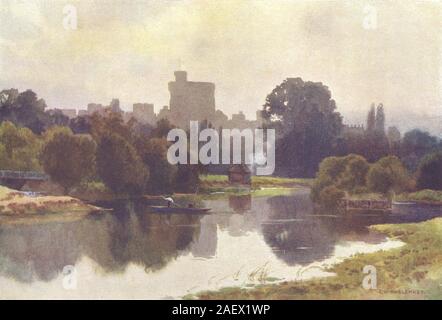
xmin=58 ymin=71 xmax=262 ymax=129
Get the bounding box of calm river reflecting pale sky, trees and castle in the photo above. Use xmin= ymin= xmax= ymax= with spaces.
xmin=0 ymin=190 xmax=442 ymax=299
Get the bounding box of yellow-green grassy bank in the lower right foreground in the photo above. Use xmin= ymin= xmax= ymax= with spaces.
xmin=187 ymin=218 xmax=442 ymax=299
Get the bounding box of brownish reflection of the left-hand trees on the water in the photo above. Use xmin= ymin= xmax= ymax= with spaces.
xmin=0 ymin=202 xmax=201 ymax=282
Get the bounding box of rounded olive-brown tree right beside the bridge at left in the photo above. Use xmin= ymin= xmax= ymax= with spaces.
xmin=41 ymin=131 xmax=96 ymax=194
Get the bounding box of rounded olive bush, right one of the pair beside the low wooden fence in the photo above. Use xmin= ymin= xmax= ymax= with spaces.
xmin=367 ymin=156 xmax=411 ymax=194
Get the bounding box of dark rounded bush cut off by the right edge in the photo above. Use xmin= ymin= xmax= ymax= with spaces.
xmin=417 ymin=151 xmax=442 ymax=190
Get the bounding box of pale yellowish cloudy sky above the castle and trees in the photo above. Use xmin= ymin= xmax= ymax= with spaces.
xmin=0 ymin=0 xmax=442 ymax=137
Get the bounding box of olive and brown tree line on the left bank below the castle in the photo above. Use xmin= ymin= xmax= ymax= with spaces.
xmin=0 ymin=89 xmax=201 ymax=195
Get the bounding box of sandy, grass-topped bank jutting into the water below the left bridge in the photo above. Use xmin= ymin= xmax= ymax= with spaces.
xmin=0 ymin=186 xmax=100 ymax=223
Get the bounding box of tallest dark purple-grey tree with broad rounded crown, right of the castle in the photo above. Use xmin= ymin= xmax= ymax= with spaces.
xmin=262 ymin=78 xmax=342 ymax=177
